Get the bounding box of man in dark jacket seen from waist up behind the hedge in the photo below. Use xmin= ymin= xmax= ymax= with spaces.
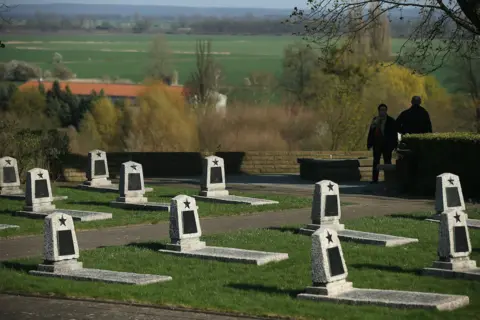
xmin=396 ymin=96 xmax=432 ymax=135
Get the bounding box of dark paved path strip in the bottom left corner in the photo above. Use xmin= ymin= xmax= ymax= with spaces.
xmin=0 ymin=294 xmax=260 ymax=320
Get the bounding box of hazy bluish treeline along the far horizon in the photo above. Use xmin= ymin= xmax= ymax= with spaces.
xmin=5 ymin=12 xmax=417 ymax=38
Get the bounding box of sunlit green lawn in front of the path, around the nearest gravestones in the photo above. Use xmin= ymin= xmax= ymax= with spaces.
xmin=0 ymin=215 xmax=480 ymax=320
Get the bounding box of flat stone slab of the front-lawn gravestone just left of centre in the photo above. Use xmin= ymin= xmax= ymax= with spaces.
xmin=159 ymin=246 xmax=288 ymax=266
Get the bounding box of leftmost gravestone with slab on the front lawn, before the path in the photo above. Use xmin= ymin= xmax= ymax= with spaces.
xmin=29 ymin=212 xmax=172 ymax=285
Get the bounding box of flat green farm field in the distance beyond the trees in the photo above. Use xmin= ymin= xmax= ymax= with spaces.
xmin=1 ymin=34 xmax=456 ymax=87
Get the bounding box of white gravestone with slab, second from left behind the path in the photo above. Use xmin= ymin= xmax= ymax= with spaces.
xmin=14 ymin=168 xmax=112 ymax=221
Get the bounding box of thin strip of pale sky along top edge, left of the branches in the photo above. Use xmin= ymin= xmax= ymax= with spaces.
xmin=6 ymin=0 xmax=306 ymax=9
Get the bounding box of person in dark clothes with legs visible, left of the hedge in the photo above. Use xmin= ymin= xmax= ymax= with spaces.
xmin=367 ymin=103 xmax=398 ymax=183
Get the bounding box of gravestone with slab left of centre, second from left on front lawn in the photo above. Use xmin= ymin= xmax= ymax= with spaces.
xmin=159 ymin=195 xmax=288 ymax=265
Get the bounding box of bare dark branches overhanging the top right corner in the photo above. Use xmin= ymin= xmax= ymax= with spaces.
xmin=287 ymin=0 xmax=480 ymax=73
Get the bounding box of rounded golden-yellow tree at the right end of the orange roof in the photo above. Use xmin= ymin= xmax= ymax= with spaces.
xmin=126 ymin=82 xmax=199 ymax=152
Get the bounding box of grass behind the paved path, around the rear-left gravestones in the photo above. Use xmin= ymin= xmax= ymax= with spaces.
xmin=0 ymin=186 xmax=312 ymax=237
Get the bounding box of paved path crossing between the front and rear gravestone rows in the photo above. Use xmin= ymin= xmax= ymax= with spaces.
xmin=0 ymin=196 xmax=433 ymax=261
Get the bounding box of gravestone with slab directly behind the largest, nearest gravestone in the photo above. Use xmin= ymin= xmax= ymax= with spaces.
xmin=299 ymin=180 xmax=418 ymax=247
